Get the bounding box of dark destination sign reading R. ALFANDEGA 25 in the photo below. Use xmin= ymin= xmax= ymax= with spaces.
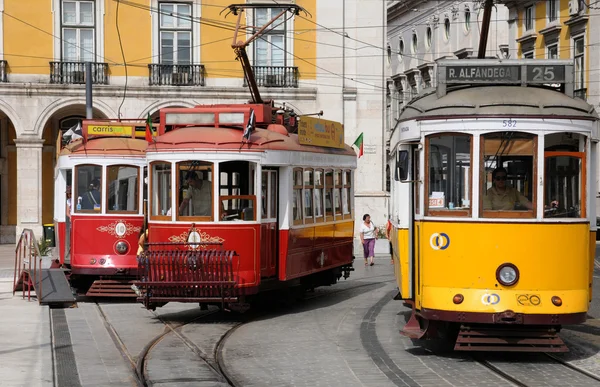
xmin=446 ymin=64 xmax=565 ymax=84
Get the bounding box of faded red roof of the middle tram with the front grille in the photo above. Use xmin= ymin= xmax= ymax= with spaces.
xmin=148 ymin=124 xmax=356 ymax=157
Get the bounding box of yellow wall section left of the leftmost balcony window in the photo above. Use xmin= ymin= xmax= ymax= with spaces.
xmin=3 ymin=0 xmax=54 ymax=74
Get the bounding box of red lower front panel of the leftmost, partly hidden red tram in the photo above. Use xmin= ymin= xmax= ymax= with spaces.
xmin=69 ymin=214 xmax=144 ymax=275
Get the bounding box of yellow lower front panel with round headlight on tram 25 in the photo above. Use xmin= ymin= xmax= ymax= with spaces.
xmin=417 ymin=222 xmax=590 ymax=323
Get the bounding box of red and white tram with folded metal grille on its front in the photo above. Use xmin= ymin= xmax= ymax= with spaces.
xmin=136 ymin=103 xmax=356 ymax=309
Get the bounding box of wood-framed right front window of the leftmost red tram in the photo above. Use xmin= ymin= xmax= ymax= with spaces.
xmin=106 ymin=165 xmax=140 ymax=213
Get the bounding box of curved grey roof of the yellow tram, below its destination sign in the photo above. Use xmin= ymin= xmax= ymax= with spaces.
xmin=399 ymin=86 xmax=598 ymax=121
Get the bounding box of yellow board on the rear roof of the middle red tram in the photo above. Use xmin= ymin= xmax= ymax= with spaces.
xmin=298 ymin=117 xmax=345 ymax=148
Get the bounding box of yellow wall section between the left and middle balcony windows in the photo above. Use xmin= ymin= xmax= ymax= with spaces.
xmin=104 ymin=0 xmax=150 ymax=77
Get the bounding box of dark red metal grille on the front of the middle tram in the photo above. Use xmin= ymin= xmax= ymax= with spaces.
xmin=135 ymin=249 xmax=238 ymax=308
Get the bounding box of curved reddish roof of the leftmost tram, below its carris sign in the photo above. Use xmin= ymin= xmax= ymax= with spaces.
xmin=60 ymin=137 xmax=148 ymax=156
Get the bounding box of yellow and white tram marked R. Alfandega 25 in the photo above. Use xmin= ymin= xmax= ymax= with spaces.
xmin=389 ymin=59 xmax=598 ymax=352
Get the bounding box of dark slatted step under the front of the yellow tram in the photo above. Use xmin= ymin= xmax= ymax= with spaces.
xmin=454 ymin=327 xmax=569 ymax=352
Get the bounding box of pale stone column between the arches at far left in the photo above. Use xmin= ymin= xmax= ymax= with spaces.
xmin=15 ymin=136 xmax=44 ymax=241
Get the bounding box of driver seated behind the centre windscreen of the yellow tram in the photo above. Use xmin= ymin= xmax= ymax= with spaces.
xmin=483 ymin=167 xmax=533 ymax=211
